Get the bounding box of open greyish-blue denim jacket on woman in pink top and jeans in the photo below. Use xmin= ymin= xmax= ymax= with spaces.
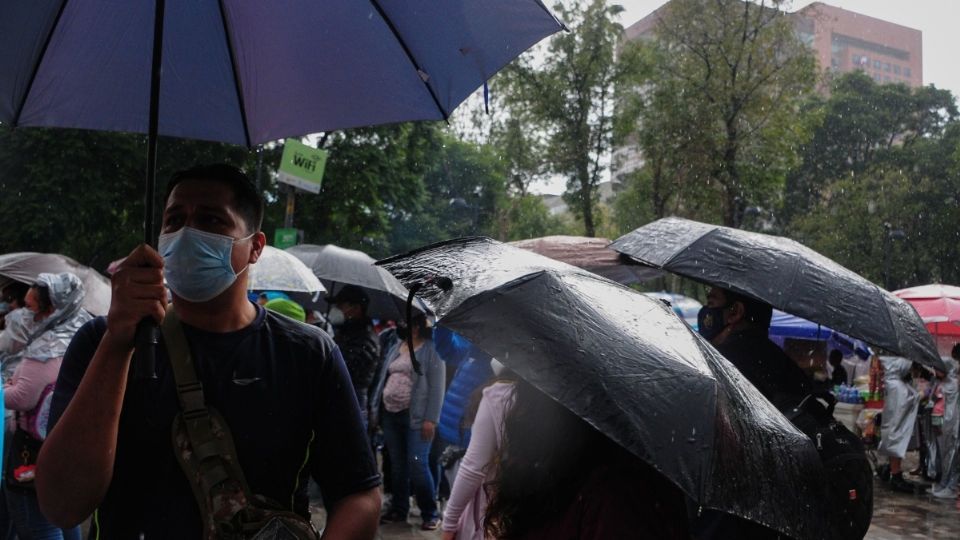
xmin=371 ymin=340 xmax=447 ymax=429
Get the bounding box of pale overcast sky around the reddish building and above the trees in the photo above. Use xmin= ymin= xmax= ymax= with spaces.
xmin=531 ymin=0 xmax=960 ymax=193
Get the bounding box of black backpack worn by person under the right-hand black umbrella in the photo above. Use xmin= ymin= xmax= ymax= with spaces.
xmin=786 ymin=392 xmax=873 ymax=540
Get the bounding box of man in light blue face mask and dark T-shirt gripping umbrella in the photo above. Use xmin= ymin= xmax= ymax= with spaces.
xmin=37 ymin=165 xmax=380 ymax=538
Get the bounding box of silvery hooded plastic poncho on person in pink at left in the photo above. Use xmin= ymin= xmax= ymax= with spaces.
xmin=22 ymin=272 xmax=93 ymax=362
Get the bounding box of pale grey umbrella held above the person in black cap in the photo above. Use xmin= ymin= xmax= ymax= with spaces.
xmin=287 ymin=244 xmax=426 ymax=321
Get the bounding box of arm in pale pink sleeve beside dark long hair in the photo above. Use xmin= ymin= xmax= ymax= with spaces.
xmin=443 ymin=386 xmax=503 ymax=532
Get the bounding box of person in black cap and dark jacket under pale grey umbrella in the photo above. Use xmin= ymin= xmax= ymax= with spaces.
xmin=328 ymin=285 xmax=380 ymax=424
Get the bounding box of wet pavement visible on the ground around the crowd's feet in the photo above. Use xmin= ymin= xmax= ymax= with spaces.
xmin=314 ymin=475 xmax=960 ymax=540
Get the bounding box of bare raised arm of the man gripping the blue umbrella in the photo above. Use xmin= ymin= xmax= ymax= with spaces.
xmin=36 ymin=245 xmax=166 ymax=527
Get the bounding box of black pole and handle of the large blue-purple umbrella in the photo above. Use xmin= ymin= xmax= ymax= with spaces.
xmin=130 ymin=0 xmax=166 ymax=380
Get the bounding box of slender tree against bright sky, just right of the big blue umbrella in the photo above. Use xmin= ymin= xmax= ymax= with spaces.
xmin=497 ymin=0 xmax=630 ymax=236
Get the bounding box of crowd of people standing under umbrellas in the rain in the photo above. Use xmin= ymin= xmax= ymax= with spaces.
xmin=0 ymin=161 xmax=944 ymax=540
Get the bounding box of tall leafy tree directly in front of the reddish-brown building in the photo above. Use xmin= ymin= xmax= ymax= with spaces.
xmin=631 ymin=0 xmax=816 ymax=227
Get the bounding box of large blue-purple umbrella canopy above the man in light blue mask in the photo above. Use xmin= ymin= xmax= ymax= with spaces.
xmin=0 ymin=0 xmax=562 ymax=146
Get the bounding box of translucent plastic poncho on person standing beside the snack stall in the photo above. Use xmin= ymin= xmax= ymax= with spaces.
xmin=878 ymin=356 xmax=920 ymax=458
